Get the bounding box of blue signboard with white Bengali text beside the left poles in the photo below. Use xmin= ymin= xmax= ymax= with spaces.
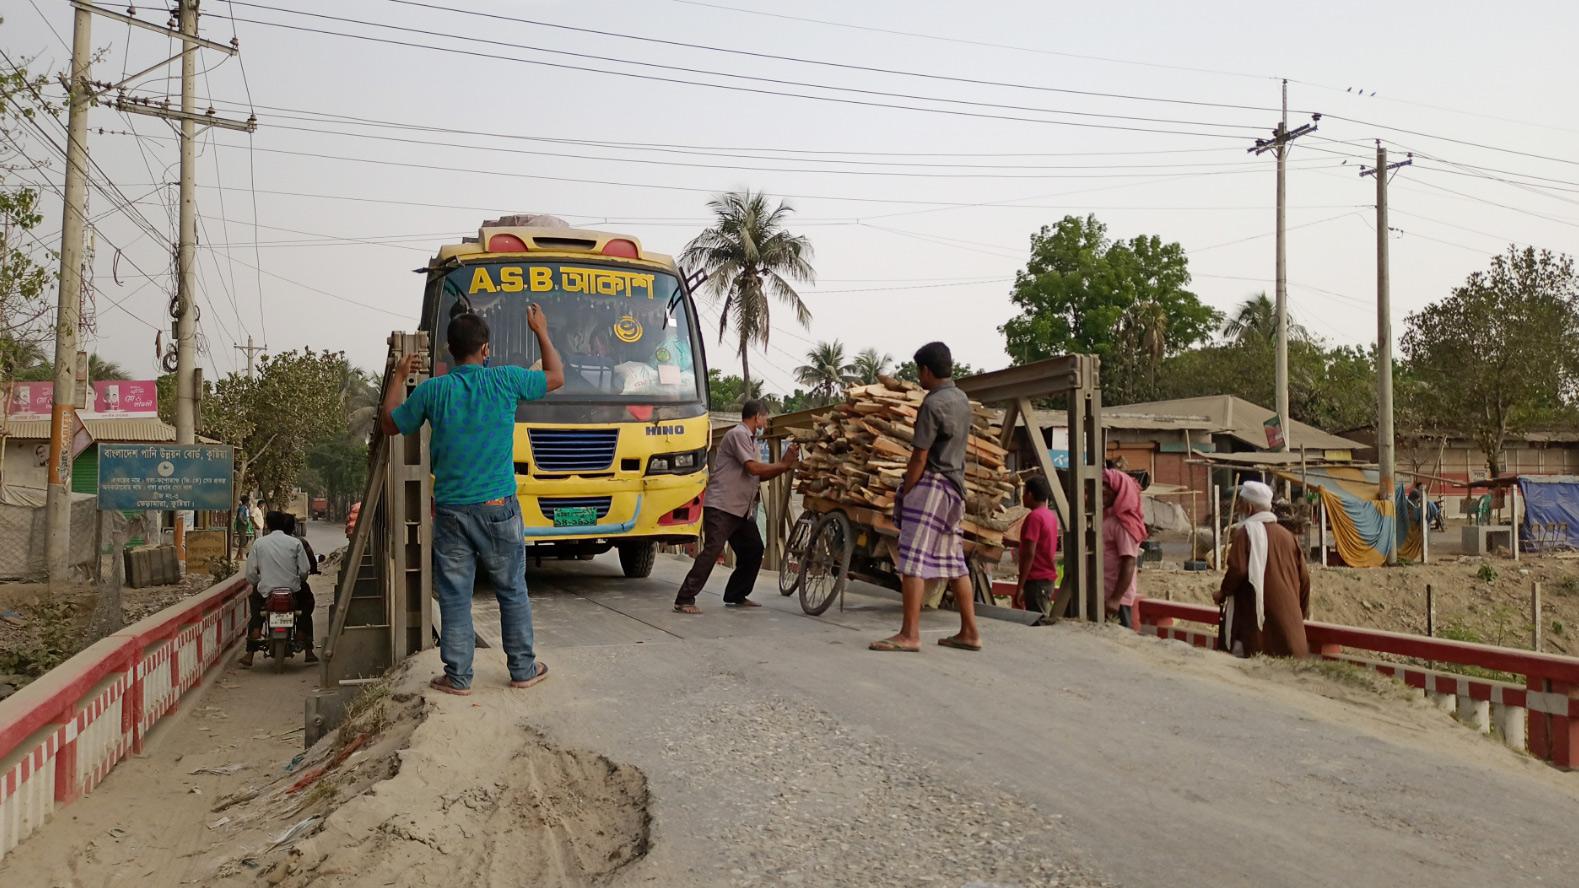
xmin=98 ymin=444 xmax=235 ymax=512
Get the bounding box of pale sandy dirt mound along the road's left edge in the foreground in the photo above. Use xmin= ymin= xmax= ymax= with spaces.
xmin=210 ymin=668 xmax=651 ymax=888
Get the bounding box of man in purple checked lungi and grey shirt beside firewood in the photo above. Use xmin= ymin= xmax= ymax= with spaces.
xmin=870 ymin=343 xmax=982 ymax=653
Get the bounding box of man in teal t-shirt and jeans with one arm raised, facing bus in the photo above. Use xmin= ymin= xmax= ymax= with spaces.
xmin=381 ymin=305 xmax=565 ymax=695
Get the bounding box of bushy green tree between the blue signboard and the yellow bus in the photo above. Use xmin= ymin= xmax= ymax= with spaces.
xmin=202 ymin=349 xmax=347 ymax=504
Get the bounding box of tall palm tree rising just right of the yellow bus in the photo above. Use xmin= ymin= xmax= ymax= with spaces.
xmin=681 ymin=191 xmax=816 ymax=387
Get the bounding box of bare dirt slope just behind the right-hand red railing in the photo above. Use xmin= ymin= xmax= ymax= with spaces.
xmin=1140 ymin=556 xmax=1579 ymax=654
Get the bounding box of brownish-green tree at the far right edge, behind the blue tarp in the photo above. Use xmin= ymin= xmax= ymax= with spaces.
xmin=1401 ymin=246 xmax=1579 ymax=476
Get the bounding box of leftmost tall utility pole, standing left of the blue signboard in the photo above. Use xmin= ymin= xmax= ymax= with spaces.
xmin=44 ymin=8 xmax=93 ymax=589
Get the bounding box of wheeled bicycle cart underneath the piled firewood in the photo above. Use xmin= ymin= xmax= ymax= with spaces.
xmin=778 ymin=496 xmax=1003 ymax=616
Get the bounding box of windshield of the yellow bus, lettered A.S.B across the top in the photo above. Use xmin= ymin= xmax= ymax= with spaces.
xmin=434 ymin=262 xmax=703 ymax=403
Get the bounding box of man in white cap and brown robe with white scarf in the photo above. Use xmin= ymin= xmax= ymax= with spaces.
xmin=1213 ymin=480 xmax=1311 ymax=657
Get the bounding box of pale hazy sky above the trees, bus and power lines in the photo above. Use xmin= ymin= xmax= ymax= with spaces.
xmin=9 ymin=0 xmax=1579 ymax=399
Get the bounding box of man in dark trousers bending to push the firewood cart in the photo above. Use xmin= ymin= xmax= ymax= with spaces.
xmin=674 ymin=400 xmax=801 ymax=615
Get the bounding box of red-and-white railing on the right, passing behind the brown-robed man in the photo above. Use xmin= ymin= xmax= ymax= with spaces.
xmin=1135 ymin=599 xmax=1579 ymax=771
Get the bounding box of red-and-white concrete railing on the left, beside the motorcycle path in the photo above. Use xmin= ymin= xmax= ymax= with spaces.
xmin=0 ymin=577 xmax=246 ymax=860
